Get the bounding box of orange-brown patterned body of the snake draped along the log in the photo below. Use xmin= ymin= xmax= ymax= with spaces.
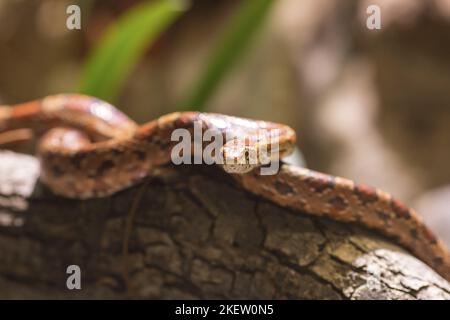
xmin=0 ymin=94 xmax=450 ymax=280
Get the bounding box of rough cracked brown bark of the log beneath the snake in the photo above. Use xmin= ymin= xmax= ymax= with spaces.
xmin=0 ymin=152 xmax=450 ymax=299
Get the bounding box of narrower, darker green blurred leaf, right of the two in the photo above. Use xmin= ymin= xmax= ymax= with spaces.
xmin=178 ymin=0 xmax=275 ymax=111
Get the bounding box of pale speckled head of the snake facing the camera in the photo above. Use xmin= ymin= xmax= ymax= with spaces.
xmin=222 ymin=140 xmax=261 ymax=174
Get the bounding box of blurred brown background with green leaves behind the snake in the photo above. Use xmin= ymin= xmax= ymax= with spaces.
xmin=0 ymin=0 xmax=450 ymax=244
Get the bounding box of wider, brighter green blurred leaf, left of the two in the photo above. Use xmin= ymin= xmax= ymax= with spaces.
xmin=78 ymin=0 xmax=186 ymax=102
